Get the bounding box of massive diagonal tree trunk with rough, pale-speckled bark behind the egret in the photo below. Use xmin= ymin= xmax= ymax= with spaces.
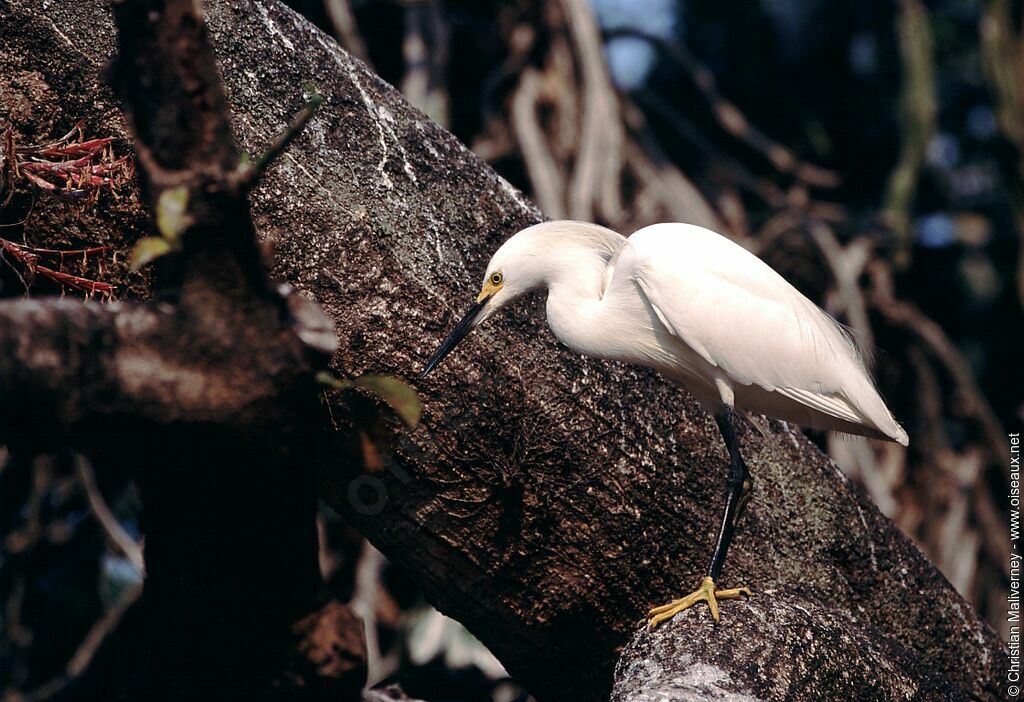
xmin=0 ymin=0 xmax=1007 ymax=702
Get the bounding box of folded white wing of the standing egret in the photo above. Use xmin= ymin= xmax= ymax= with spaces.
xmin=620 ymin=225 xmax=892 ymax=425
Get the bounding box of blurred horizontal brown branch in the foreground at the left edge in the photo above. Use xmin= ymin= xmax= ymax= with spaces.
xmin=0 ymin=298 xmax=331 ymax=448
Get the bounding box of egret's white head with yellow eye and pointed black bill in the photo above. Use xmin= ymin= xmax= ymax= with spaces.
xmin=420 ymin=227 xmax=544 ymax=378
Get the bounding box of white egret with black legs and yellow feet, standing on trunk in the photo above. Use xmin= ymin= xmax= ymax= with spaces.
xmin=421 ymin=221 xmax=907 ymax=626
